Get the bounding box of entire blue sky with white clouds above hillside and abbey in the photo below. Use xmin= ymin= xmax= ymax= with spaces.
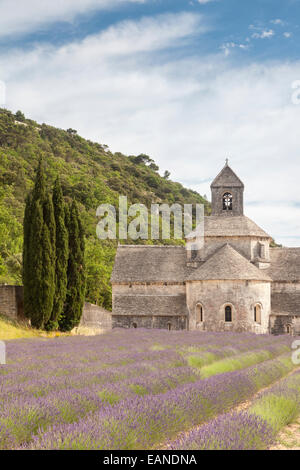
xmin=0 ymin=0 xmax=300 ymax=246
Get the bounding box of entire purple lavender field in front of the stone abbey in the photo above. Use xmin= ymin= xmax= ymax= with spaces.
xmin=0 ymin=329 xmax=300 ymax=450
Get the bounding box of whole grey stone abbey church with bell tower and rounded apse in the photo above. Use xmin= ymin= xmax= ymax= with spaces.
xmin=111 ymin=163 xmax=300 ymax=334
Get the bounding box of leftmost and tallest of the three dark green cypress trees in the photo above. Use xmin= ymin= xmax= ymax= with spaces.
xmin=23 ymin=161 xmax=55 ymax=328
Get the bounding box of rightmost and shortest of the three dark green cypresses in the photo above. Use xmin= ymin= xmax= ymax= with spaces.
xmin=59 ymin=201 xmax=85 ymax=331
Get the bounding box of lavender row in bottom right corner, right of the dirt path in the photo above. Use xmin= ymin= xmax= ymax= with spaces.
xmin=169 ymin=371 xmax=300 ymax=450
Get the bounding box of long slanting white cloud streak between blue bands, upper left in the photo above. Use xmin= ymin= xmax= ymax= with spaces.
xmin=0 ymin=13 xmax=207 ymax=76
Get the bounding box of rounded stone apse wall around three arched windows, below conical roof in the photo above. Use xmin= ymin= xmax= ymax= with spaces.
xmin=187 ymin=281 xmax=271 ymax=334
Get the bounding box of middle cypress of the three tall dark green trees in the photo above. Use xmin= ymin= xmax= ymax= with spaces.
xmin=46 ymin=178 xmax=69 ymax=330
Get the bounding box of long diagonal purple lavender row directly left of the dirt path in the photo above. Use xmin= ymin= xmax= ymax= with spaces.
xmin=20 ymin=357 xmax=293 ymax=450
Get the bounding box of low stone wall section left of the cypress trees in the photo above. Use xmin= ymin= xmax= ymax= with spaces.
xmin=0 ymin=286 xmax=23 ymax=320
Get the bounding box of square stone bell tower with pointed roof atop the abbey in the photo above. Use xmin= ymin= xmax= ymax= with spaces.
xmin=210 ymin=159 xmax=244 ymax=216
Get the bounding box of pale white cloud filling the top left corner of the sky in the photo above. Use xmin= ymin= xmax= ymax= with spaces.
xmin=0 ymin=0 xmax=146 ymax=37
